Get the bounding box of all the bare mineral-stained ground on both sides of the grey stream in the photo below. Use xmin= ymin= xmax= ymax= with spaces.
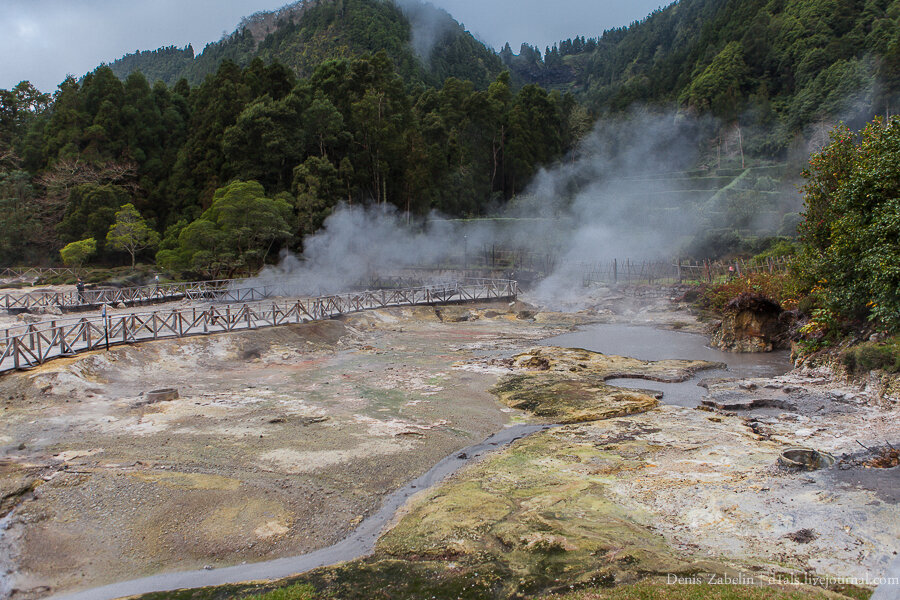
xmin=0 ymin=289 xmax=900 ymax=598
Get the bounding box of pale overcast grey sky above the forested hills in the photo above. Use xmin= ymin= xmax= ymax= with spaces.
xmin=0 ymin=0 xmax=663 ymax=92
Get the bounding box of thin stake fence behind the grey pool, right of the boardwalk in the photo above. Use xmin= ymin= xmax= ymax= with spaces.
xmin=582 ymin=258 xmax=790 ymax=286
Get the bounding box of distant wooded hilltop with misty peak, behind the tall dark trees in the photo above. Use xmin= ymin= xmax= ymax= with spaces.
xmin=109 ymin=0 xmax=503 ymax=89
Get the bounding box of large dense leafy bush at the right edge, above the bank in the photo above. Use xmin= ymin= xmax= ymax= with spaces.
xmin=800 ymin=117 xmax=900 ymax=330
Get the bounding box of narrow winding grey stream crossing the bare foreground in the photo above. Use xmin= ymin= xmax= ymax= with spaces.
xmin=50 ymin=425 xmax=553 ymax=600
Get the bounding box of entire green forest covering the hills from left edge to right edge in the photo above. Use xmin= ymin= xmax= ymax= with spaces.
xmin=0 ymin=0 xmax=900 ymax=277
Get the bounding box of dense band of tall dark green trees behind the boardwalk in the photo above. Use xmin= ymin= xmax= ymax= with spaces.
xmin=0 ymin=51 xmax=576 ymax=276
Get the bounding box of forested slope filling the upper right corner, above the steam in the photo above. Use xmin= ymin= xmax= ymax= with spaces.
xmin=501 ymin=0 xmax=900 ymax=155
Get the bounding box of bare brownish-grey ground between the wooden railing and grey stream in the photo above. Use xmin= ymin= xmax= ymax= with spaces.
xmin=0 ymin=304 xmax=564 ymax=599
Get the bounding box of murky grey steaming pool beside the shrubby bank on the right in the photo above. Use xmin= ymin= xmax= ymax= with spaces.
xmin=540 ymin=323 xmax=791 ymax=407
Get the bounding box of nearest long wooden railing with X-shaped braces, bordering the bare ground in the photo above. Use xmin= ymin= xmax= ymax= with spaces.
xmin=0 ymin=279 xmax=518 ymax=373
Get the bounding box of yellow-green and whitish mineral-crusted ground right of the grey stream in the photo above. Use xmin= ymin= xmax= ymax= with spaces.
xmin=125 ymin=340 xmax=900 ymax=600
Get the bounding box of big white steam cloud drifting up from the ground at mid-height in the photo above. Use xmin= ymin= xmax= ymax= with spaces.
xmin=246 ymin=112 xmax=768 ymax=302
